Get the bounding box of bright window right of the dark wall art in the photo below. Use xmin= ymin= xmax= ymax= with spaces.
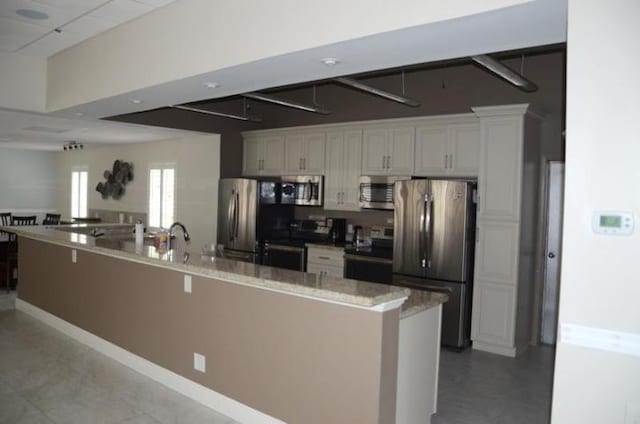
xmin=149 ymin=165 xmax=175 ymax=228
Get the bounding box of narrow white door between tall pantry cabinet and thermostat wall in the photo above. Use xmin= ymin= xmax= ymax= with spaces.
xmin=541 ymin=162 xmax=564 ymax=344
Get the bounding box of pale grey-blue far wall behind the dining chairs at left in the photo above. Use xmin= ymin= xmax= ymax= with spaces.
xmin=0 ymin=149 xmax=58 ymax=213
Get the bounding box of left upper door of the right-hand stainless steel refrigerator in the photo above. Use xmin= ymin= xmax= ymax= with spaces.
xmin=393 ymin=180 xmax=428 ymax=277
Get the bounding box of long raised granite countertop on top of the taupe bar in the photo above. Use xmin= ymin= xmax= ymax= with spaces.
xmin=0 ymin=224 xmax=410 ymax=308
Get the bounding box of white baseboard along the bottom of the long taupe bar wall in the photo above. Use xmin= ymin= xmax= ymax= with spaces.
xmin=16 ymin=299 xmax=284 ymax=424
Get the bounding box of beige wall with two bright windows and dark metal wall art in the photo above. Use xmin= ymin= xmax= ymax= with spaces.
xmin=58 ymin=135 xmax=220 ymax=251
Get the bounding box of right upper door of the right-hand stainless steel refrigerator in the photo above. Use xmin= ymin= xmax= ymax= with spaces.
xmin=426 ymin=180 xmax=470 ymax=281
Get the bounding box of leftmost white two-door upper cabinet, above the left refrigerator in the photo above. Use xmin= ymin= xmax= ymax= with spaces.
xmin=242 ymin=136 xmax=284 ymax=176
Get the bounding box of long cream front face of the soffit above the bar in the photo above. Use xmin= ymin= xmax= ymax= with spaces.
xmin=47 ymin=0 xmax=529 ymax=110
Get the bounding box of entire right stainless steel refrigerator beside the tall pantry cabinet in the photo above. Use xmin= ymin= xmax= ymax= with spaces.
xmin=393 ymin=179 xmax=476 ymax=348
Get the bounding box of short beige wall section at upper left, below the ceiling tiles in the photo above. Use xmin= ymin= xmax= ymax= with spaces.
xmin=0 ymin=52 xmax=47 ymax=112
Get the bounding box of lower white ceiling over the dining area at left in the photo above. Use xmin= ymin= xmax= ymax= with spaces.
xmin=0 ymin=108 xmax=202 ymax=150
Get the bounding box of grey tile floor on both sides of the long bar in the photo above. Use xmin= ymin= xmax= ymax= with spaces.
xmin=0 ymin=292 xmax=554 ymax=424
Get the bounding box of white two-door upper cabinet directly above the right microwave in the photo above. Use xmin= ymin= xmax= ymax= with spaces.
xmin=362 ymin=127 xmax=415 ymax=175
